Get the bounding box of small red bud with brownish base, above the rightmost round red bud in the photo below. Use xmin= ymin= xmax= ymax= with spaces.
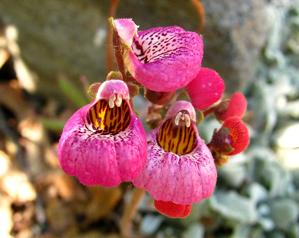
xmin=214 ymin=92 xmax=247 ymax=121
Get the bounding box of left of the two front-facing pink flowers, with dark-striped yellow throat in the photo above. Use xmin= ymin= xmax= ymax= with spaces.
xmin=58 ymin=80 xmax=146 ymax=187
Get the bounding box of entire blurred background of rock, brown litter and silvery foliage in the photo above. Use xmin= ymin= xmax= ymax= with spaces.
xmin=0 ymin=0 xmax=299 ymax=238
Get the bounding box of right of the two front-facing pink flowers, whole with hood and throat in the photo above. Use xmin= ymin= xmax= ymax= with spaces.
xmin=133 ymin=101 xmax=217 ymax=205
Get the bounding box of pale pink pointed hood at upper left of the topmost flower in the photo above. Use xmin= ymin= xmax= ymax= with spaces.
xmin=113 ymin=18 xmax=138 ymax=47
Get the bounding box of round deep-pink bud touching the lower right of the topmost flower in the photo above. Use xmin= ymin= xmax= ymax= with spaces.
xmin=187 ymin=68 xmax=225 ymax=110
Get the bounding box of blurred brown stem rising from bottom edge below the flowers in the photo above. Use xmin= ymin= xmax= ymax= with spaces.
xmin=120 ymin=188 xmax=145 ymax=238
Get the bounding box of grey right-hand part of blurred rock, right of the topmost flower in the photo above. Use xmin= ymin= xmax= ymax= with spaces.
xmin=202 ymin=0 xmax=271 ymax=92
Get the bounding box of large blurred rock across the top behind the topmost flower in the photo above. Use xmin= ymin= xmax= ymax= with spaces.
xmin=0 ymin=0 xmax=276 ymax=95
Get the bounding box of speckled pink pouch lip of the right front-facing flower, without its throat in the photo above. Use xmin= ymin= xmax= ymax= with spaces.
xmin=133 ymin=129 xmax=217 ymax=205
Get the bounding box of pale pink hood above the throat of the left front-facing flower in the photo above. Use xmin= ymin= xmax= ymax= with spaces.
xmin=96 ymin=79 xmax=130 ymax=101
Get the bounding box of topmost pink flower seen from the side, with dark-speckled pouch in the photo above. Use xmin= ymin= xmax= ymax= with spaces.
xmin=113 ymin=19 xmax=203 ymax=92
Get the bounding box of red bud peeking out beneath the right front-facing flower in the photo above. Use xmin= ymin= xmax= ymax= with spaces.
xmin=154 ymin=200 xmax=192 ymax=218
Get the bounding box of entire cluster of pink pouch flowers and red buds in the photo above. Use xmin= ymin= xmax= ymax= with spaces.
xmin=58 ymin=19 xmax=249 ymax=218
